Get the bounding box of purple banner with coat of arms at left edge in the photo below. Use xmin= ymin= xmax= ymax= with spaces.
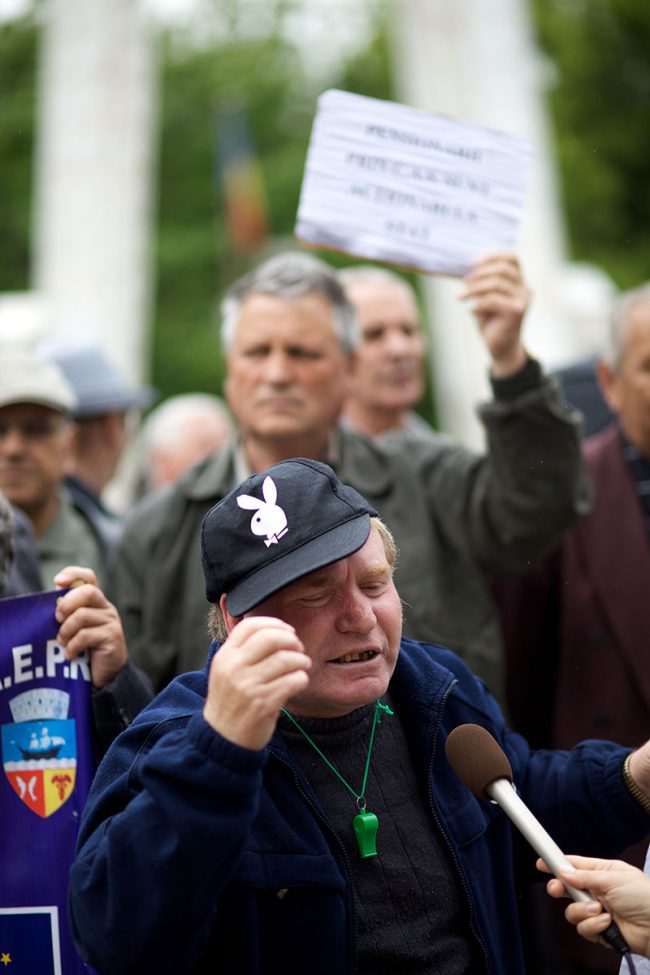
xmin=0 ymin=590 xmax=94 ymax=975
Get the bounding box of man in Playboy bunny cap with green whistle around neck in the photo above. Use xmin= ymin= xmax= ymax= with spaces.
xmin=70 ymin=458 xmax=650 ymax=975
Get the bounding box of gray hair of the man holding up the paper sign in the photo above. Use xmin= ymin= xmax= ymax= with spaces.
xmin=221 ymin=251 xmax=360 ymax=355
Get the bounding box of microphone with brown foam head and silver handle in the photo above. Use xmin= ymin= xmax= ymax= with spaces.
xmin=445 ymin=724 xmax=630 ymax=955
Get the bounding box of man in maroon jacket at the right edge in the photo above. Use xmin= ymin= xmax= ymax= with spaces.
xmin=496 ymin=284 xmax=650 ymax=973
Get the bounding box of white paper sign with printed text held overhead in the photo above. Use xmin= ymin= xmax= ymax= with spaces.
xmin=295 ymin=89 xmax=531 ymax=276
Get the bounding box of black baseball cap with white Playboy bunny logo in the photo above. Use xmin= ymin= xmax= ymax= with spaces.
xmin=201 ymin=457 xmax=377 ymax=616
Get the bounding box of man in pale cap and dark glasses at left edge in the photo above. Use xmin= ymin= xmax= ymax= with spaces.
xmin=0 ymin=353 xmax=104 ymax=588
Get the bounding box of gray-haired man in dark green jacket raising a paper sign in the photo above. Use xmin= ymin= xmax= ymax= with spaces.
xmin=109 ymin=253 xmax=588 ymax=696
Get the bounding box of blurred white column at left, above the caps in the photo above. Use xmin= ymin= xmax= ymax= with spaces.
xmin=32 ymin=0 xmax=156 ymax=382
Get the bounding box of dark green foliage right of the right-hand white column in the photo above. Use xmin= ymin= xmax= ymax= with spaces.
xmin=534 ymin=0 xmax=650 ymax=287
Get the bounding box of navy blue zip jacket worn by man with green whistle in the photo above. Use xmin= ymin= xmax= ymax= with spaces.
xmin=70 ymin=640 xmax=649 ymax=975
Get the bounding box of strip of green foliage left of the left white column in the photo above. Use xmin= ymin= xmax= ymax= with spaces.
xmin=0 ymin=15 xmax=38 ymax=291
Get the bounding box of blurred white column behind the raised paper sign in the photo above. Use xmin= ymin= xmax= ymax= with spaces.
xmin=392 ymin=0 xmax=580 ymax=447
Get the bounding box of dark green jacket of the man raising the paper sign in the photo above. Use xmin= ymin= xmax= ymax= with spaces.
xmin=108 ymin=361 xmax=590 ymax=699
